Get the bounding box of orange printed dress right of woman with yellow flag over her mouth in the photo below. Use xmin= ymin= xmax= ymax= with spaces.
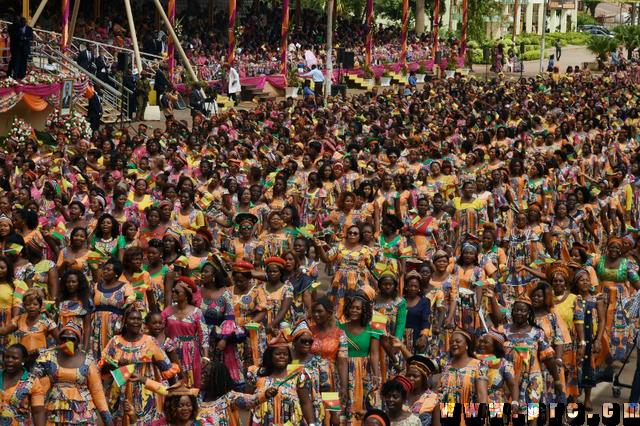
xmin=98 ymin=334 xmax=180 ymax=426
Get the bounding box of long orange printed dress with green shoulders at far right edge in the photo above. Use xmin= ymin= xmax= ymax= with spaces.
xmin=595 ymin=256 xmax=640 ymax=360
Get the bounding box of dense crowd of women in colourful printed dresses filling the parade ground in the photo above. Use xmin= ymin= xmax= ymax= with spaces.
xmin=0 ymin=61 xmax=640 ymax=426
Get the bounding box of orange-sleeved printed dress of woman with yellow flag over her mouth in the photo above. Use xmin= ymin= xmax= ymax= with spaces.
xmin=33 ymin=349 xmax=112 ymax=426
